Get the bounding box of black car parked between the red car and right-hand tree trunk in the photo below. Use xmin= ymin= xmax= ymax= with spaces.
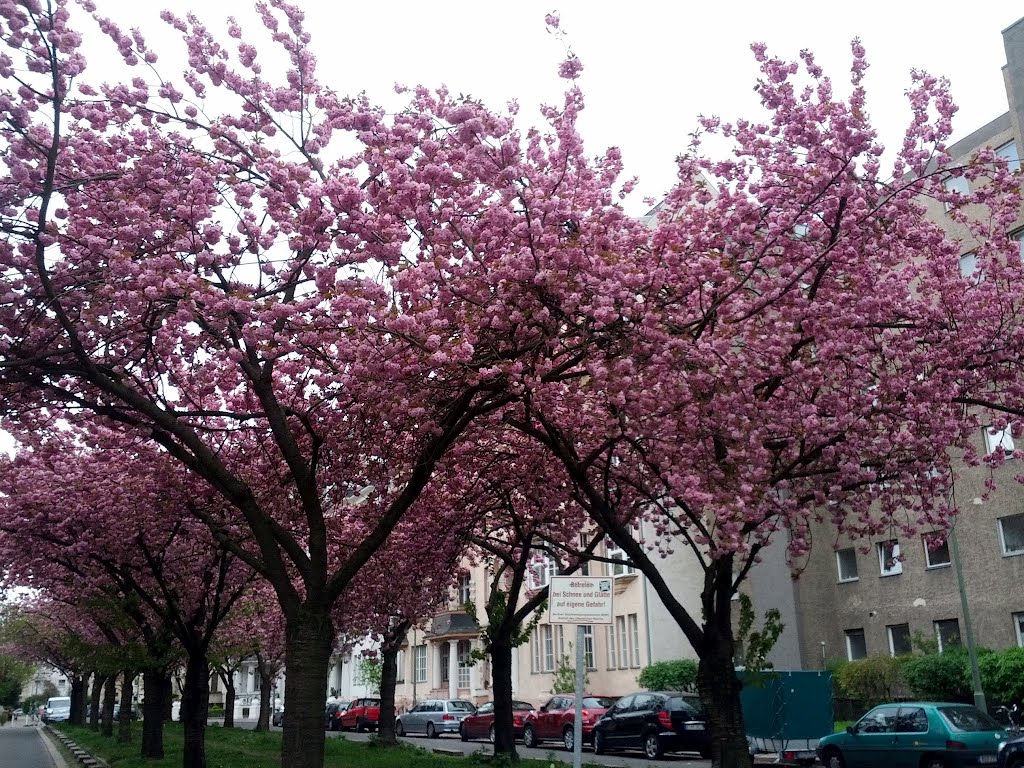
xmin=593 ymin=691 xmax=711 ymax=760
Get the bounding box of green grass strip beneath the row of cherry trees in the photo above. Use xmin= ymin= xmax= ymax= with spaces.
xmin=56 ymin=723 xmax=577 ymax=768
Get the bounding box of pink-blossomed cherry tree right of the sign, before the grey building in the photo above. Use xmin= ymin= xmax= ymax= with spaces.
xmin=506 ymin=42 xmax=1022 ymax=768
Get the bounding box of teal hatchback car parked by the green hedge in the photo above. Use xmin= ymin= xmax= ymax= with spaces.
xmin=817 ymin=701 xmax=1007 ymax=768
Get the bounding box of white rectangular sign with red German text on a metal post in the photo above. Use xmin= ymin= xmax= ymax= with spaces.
xmin=548 ymin=575 xmax=613 ymax=768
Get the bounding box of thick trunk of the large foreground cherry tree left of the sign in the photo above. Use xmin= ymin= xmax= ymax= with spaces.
xmin=281 ymin=603 xmax=334 ymax=768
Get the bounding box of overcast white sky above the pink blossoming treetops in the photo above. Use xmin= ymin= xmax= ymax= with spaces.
xmin=75 ymin=0 xmax=1024 ymax=208
